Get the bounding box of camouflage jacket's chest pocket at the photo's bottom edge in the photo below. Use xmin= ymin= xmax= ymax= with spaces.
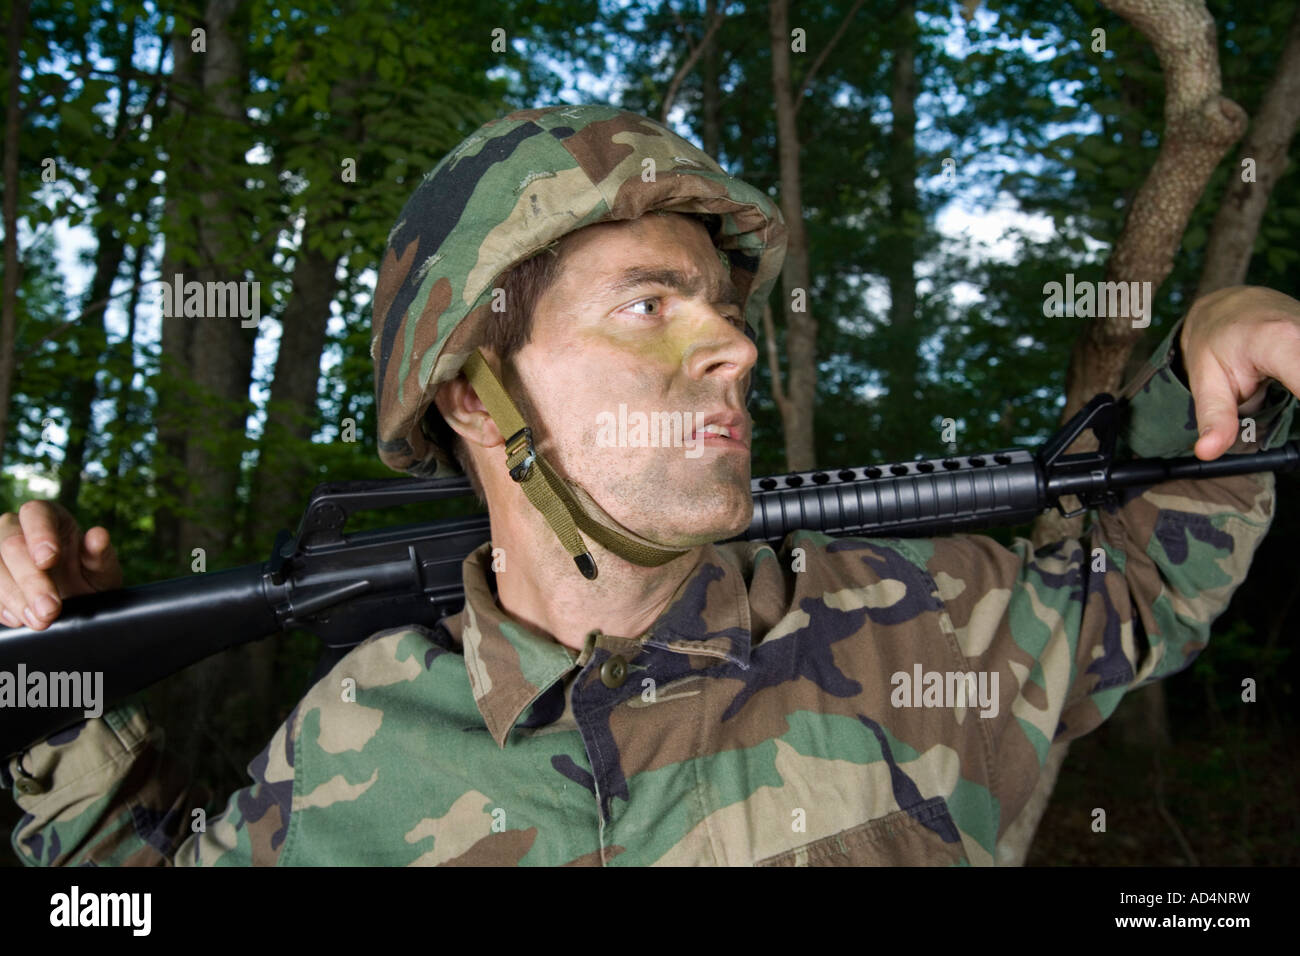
xmin=755 ymin=796 xmax=970 ymax=866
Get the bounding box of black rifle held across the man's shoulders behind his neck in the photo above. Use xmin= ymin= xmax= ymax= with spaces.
xmin=0 ymin=395 xmax=1300 ymax=754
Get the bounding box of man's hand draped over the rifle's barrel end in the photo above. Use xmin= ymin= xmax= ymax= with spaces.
xmin=1179 ymin=286 xmax=1300 ymax=462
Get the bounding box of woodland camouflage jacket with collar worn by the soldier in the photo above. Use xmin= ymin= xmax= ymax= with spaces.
xmin=9 ymin=328 xmax=1295 ymax=865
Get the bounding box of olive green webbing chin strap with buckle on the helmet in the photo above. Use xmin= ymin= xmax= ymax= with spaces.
xmin=465 ymin=349 xmax=692 ymax=580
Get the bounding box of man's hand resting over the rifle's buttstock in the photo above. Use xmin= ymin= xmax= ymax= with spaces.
xmin=0 ymin=501 xmax=122 ymax=631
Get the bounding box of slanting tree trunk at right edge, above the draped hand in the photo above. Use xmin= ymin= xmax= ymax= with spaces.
xmin=1196 ymin=8 xmax=1300 ymax=298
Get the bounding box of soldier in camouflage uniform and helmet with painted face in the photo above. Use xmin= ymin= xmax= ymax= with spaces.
xmin=0 ymin=105 xmax=1300 ymax=865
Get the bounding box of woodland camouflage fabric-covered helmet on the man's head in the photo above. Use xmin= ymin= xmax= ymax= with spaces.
xmin=371 ymin=105 xmax=785 ymax=477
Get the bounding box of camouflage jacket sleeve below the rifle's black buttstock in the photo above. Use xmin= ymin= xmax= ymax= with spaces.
xmin=5 ymin=705 xmax=298 ymax=866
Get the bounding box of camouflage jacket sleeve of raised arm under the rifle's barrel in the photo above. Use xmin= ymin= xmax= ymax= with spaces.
xmin=905 ymin=323 xmax=1296 ymax=835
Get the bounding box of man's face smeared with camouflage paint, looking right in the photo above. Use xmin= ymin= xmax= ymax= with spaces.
xmin=501 ymin=215 xmax=758 ymax=546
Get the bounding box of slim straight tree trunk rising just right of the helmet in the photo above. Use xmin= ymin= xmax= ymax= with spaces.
xmin=770 ymin=0 xmax=816 ymax=471
